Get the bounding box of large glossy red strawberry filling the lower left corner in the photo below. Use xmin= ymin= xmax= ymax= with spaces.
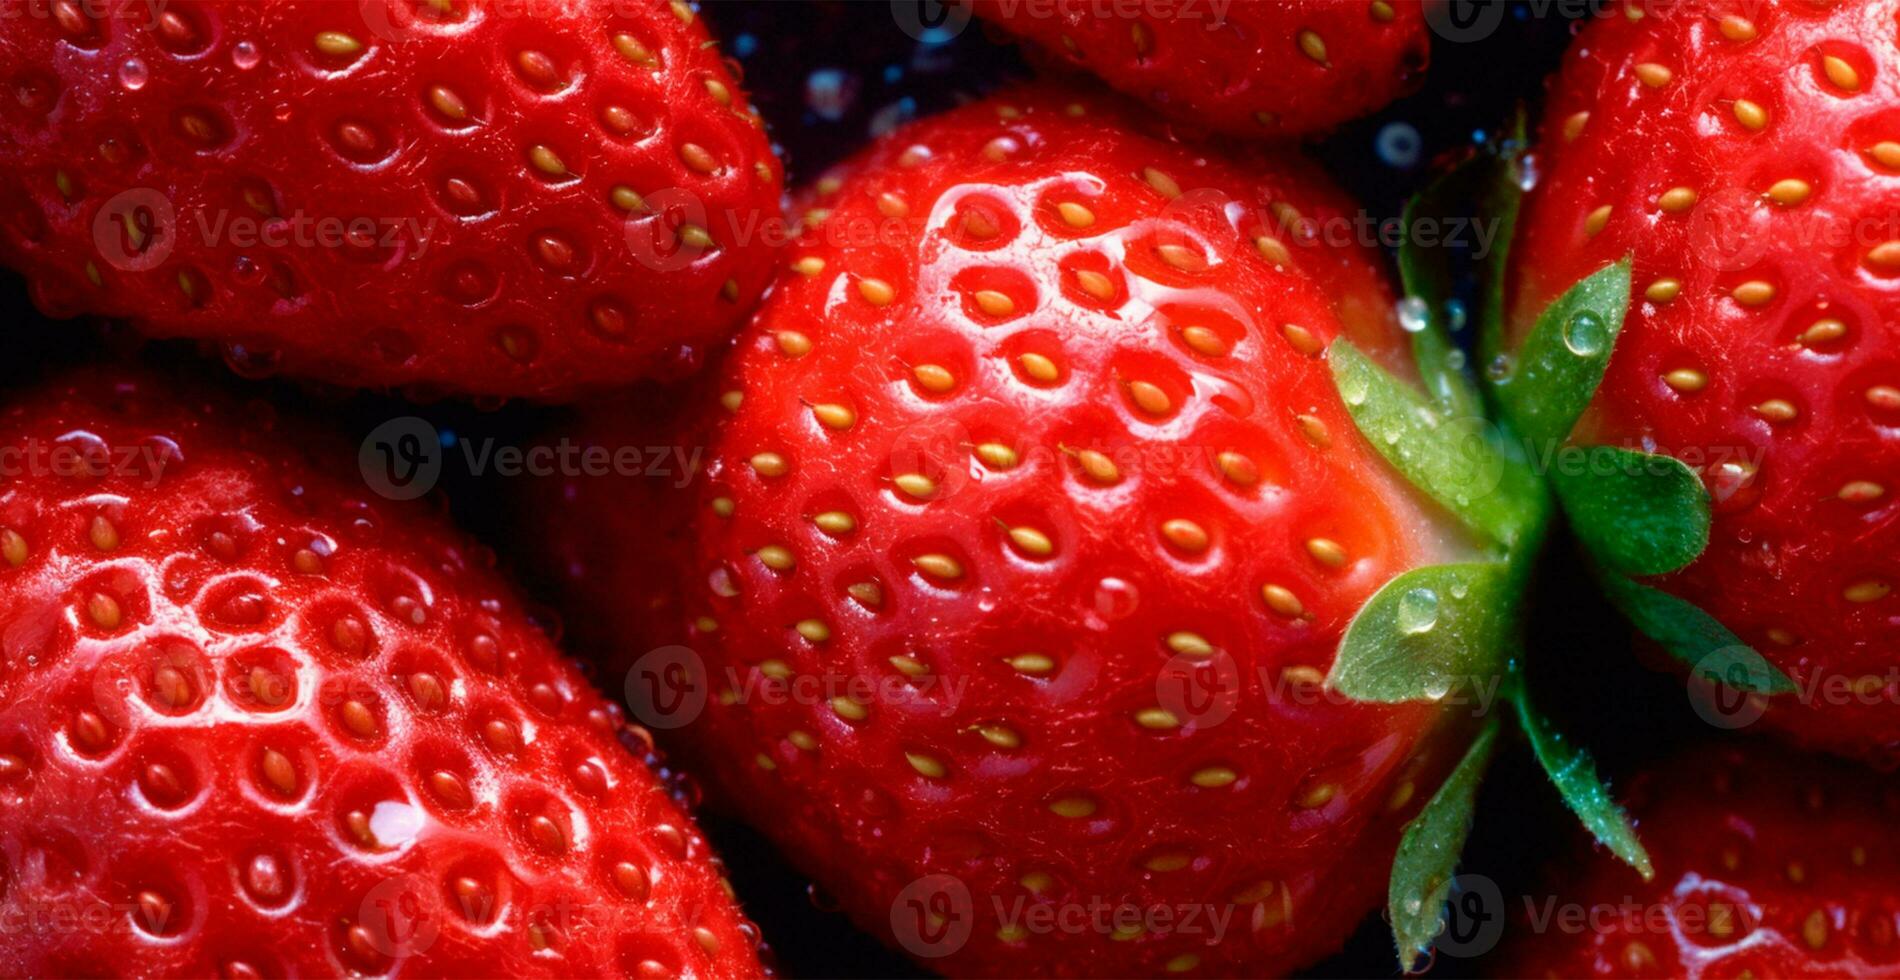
xmin=0 ymin=362 xmax=762 ymax=976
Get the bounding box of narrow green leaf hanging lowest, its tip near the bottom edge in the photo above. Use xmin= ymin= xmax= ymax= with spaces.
xmin=1385 ymin=716 xmax=1501 ymax=972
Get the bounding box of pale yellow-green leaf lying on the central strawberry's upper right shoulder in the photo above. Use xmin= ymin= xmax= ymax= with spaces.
xmin=1330 ymin=338 xmax=1537 ymax=545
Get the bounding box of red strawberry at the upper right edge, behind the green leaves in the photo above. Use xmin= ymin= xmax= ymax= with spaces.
xmin=1509 ymin=0 xmax=1900 ymax=765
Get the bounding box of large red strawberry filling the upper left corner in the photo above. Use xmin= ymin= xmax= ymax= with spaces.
xmin=0 ymin=0 xmax=783 ymax=399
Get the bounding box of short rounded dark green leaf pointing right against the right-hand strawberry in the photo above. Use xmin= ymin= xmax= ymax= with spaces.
xmin=1550 ymin=446 xmax=1710 ymax=575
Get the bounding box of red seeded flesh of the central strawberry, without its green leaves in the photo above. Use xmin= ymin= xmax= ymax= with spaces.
xmin=625 ymin=89 xmax=1473 ymax=976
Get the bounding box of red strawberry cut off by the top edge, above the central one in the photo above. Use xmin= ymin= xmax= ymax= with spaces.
xmin=973 ymin=0 xmax=1431 ymax=137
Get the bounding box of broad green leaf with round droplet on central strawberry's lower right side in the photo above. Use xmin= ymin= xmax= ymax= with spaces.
xmin=1326 ymin=562 xmax=1516 ymax=703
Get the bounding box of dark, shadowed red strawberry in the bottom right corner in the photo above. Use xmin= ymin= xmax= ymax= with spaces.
xmin=1495 ymin=743 xmax=1900 ymax=978
